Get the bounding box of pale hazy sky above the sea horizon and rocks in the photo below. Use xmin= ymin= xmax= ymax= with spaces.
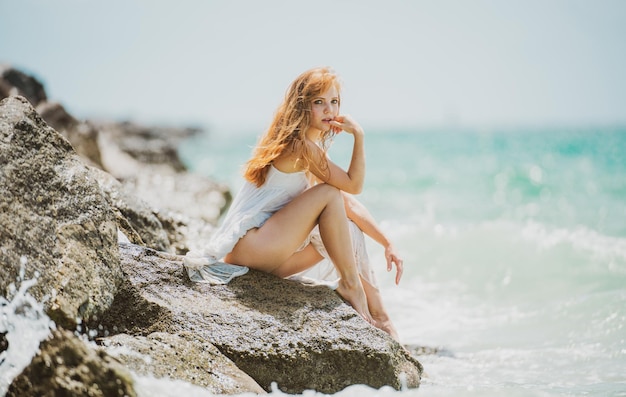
xmin=0 ymin=0 xmax=626 ymax=129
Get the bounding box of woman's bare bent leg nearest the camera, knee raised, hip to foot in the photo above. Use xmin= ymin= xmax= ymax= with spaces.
xmin=224 ymin=184 xmax=373 ymax=323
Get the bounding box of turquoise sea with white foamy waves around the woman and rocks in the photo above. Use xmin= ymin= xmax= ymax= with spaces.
xmin=5 ymin=126 xmax=626 ymax=397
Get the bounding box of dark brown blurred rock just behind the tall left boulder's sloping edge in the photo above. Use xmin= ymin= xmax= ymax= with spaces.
xmin=37 ymin=102 xmax=104 ymax=169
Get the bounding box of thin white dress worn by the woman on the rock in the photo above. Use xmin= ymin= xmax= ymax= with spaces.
xmin=184 ymin=166 xmax=376 ymax=286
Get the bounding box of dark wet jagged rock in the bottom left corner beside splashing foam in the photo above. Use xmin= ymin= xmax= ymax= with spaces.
xmin=6 ymin=330 xmax=136 ymax=397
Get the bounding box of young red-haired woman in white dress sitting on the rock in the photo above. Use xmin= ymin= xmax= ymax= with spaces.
xmin=185 ymin=68 xmax=402 ymax=339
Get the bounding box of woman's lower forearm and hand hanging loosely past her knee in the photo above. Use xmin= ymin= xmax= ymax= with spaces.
xmin=343 ymin=193 xmax=404 ymax=284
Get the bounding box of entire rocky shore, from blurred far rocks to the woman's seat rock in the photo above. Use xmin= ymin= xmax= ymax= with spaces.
xmin=0 ymin=66 xmax=422 ymax=396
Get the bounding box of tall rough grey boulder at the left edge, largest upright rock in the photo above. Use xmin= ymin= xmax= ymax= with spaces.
xmin=0 ymin=97 xmax=123 ymax=329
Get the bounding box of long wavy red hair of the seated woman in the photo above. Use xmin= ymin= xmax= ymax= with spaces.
xmin=244 ymin=67 xmax=341 ymax=187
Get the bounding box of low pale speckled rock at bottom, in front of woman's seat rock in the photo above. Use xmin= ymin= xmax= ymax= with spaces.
xmin=99 ymin=333 xmax=265 ymax=394
